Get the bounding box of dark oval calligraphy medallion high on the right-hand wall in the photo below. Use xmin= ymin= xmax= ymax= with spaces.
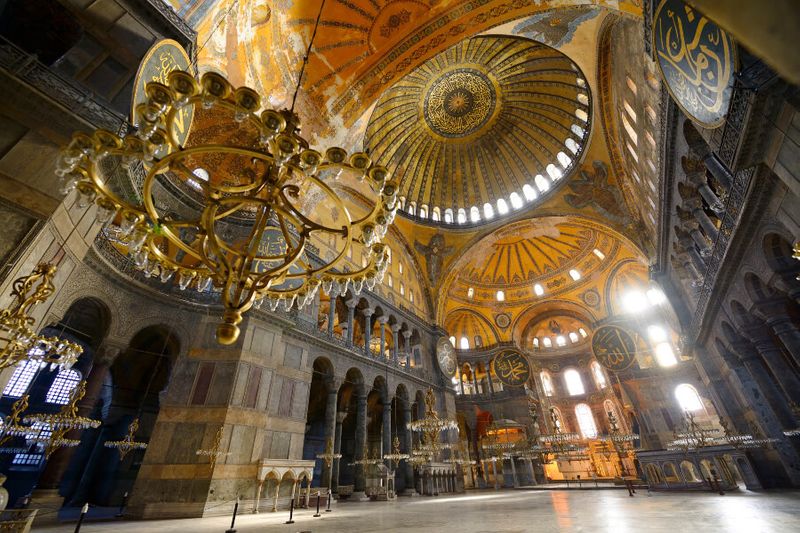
xmin=653 ymin=0 xmax=736 ymax=127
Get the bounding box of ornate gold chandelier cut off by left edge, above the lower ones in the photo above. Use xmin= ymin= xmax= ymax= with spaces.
xmin=0 ymin=263 xmax=83 ymax=370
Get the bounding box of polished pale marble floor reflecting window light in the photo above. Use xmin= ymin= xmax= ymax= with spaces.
xmin=35 ymin=490 xmax=800 ymax=533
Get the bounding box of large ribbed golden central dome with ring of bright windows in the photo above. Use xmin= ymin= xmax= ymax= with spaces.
xmin=364 ymin=36 xmax=590 ymax=226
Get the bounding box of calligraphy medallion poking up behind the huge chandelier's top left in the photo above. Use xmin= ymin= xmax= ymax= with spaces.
xmin=131 ymin=39 xmax=194 ymax=145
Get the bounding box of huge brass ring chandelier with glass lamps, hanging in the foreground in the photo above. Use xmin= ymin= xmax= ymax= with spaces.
xmin=57 ymin=2 xmax=397 ymax=344
